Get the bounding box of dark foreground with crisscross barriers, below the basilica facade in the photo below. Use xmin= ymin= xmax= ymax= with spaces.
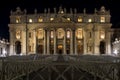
xmin=0 ymin=55 xmax=120 ymax=80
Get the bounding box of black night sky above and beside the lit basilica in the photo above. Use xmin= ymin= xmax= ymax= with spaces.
xmin=0 ymin=0 xmax=120 ymax=39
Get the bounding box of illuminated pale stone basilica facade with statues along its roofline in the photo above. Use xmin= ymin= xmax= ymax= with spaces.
xmin=8 ymin=6 xmax=112 ymax=55
